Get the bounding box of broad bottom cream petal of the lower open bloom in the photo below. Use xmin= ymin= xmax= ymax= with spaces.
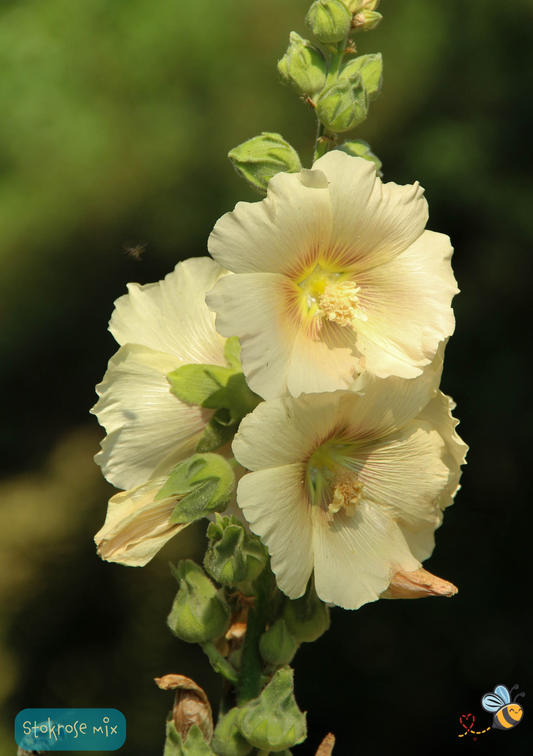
xmin=313 ymin=502 xmax=420 ymax=609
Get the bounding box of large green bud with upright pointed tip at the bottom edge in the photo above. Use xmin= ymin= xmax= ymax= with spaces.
xmin=237 ymin=667 xmax=306 ymax=751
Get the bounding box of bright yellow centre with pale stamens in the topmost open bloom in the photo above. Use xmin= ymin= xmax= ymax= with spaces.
xmin=298 ymin=265 xmax=367 ymax=326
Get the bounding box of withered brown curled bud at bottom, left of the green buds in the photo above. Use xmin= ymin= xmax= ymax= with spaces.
xmin=155 ymin=675 xmax=213 ymax=743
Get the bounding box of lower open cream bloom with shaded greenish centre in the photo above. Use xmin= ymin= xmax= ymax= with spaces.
xmin=233 ymin=357 xmax=466 ymax=609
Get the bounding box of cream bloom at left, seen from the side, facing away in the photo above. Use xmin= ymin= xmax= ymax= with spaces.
xmin=91 ymin=258 xmax=228 ymax=490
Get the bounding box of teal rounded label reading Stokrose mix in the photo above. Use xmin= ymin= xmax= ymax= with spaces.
xmin=15 ymin=709 xmax=126 ymax=752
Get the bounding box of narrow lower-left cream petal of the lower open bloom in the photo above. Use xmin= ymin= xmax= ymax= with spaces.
xmin=237 ymin=464 xmax=313 ymax=599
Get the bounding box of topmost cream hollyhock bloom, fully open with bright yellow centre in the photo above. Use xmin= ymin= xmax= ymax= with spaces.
xmin=207 ymin=151 xmax=458 ymax=399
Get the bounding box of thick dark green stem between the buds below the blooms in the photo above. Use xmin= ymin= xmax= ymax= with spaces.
xmin=237 ymin=564 xmax=272 ymax=706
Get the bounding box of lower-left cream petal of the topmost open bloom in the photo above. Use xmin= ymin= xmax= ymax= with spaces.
xmin=206 ymin=273 xmax=297 ymax=399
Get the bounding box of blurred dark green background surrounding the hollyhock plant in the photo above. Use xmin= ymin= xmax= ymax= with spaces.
xmin=0 ymin=0 xmax=533 ymax=756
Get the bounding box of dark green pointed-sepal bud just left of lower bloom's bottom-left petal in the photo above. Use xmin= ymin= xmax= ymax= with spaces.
xmin=204 ymin=515 xmax=268 ymax=586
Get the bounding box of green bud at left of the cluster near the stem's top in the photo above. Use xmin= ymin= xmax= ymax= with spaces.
xmin=278 ymin=32 xmax=328 ymax=97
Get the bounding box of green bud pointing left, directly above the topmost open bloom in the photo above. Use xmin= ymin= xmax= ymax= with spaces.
xmin=228 ymin=131 xmax=302 ymax=194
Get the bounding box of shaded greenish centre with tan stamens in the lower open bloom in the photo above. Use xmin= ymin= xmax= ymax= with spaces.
xmin=307 ymin=444 xmax=365 ymax=521
